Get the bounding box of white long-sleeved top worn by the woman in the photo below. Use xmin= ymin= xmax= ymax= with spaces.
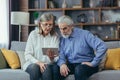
xmin=23 ymin=28 xmax=59 ymax=70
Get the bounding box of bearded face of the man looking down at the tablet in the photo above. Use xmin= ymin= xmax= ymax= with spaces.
xmin=58 ymin=23 xmax=73 ymax=38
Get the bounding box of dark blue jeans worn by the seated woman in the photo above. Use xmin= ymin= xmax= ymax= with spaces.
xmin=26 ymin=63 xmax=53 ymax=80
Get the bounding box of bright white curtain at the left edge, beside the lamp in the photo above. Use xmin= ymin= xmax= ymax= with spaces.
xmin=0 ymin=0 xmax=9 ymax=48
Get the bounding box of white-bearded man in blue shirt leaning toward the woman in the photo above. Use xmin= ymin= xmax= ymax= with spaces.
xmin=54 ymin=15 xmax=107 ymax=80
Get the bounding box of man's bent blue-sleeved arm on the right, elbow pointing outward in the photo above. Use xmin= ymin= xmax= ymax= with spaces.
xmin=86 ymin=32 xmax=107 ymax=67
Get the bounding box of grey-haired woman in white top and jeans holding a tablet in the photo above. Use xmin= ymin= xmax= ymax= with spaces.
xmin=23 ymin=13 xmax=59 ymax=80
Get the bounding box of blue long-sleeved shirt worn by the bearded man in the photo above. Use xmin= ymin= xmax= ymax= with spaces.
xmin=58 ymin=28 xmax=107 ymax=67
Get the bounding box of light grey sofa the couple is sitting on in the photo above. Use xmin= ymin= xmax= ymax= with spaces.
xmin=0 ymin=41 xmax=120 ymax=80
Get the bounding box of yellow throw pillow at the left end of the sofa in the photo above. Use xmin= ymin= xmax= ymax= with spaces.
xmin=1 ymin=48 xmax=20 ymax=69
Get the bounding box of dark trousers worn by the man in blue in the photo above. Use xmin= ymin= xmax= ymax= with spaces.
xmin=54 ymin=63 xmax=98 ymax=80
